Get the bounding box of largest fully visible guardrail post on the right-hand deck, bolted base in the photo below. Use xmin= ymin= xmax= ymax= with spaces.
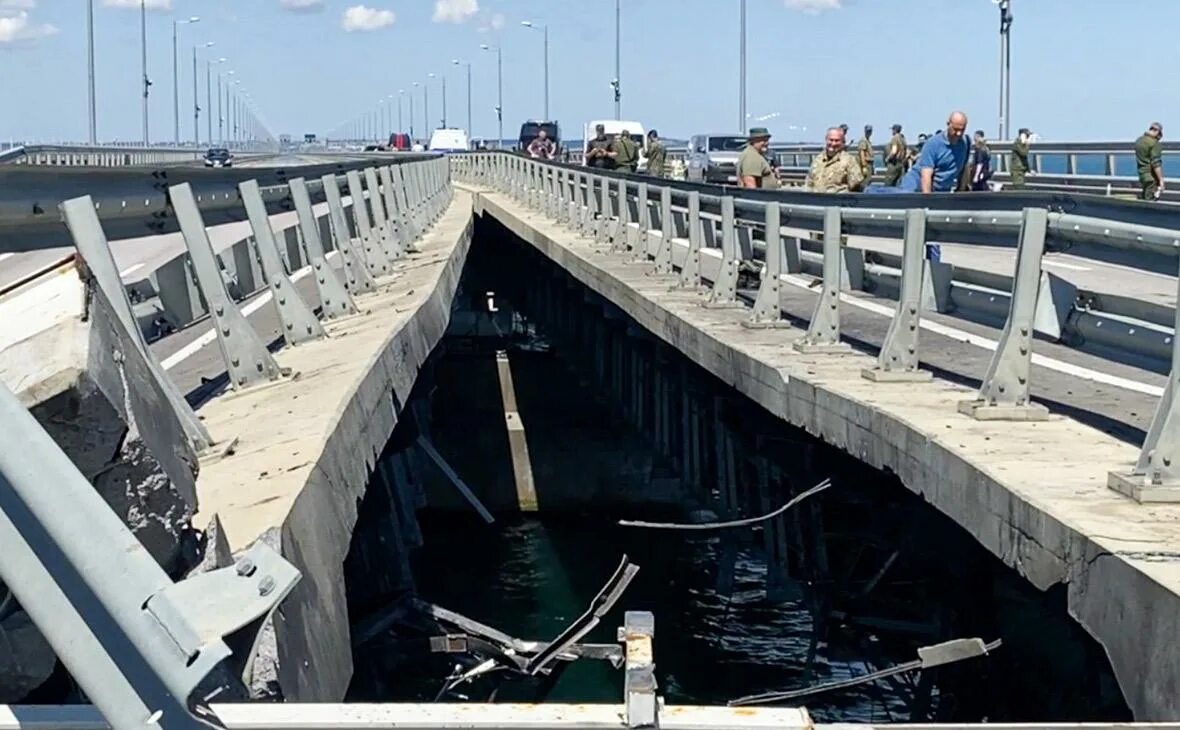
xmin=958 ymin=208 xmax=1049 ymax=421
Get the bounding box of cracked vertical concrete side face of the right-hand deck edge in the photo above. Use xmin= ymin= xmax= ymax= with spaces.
xmin=474 ymin=187 xmax=1180 ymax=722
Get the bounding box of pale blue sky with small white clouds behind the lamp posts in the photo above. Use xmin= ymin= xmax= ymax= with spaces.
xmin=0 ymin=0 xmax=1180 ymax=142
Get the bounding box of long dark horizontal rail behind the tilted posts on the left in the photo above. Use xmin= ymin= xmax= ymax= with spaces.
xmin=0 ymin=153 xmax=433 ymax=254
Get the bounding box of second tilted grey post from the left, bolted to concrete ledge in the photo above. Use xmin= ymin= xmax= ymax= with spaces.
xmin=169 ymin=183 xmax=281 ymax=389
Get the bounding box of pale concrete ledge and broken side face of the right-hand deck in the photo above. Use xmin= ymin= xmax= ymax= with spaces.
xmin=462 ymin=182 xmax=1180 ymax=719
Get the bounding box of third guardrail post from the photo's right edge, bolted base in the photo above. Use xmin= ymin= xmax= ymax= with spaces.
xmin=860 ymin=209 xmax=933 ymax=383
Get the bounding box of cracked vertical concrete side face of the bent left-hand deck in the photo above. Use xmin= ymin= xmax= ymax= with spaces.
xmin=275 ymin=193 xmax=474 ymax=702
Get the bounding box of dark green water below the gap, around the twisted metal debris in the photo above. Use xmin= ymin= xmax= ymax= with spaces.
xmin=415 ymin=514 xmax=913 ymax=721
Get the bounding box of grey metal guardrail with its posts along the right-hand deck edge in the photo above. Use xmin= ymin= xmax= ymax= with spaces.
xmin=452 ymin=152 xmax=1180 ymax=501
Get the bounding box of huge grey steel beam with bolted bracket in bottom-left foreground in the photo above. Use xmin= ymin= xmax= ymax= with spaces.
xmin=0 ymin=382 xmax=299 ymax=728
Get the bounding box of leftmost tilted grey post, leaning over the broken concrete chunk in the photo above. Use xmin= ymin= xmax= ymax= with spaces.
xmin=59 ymin=196 xmax=214 ymax=452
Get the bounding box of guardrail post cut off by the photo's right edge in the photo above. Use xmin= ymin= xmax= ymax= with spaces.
xmin=1107 ymin=257 xmax=1180 ymax=502
